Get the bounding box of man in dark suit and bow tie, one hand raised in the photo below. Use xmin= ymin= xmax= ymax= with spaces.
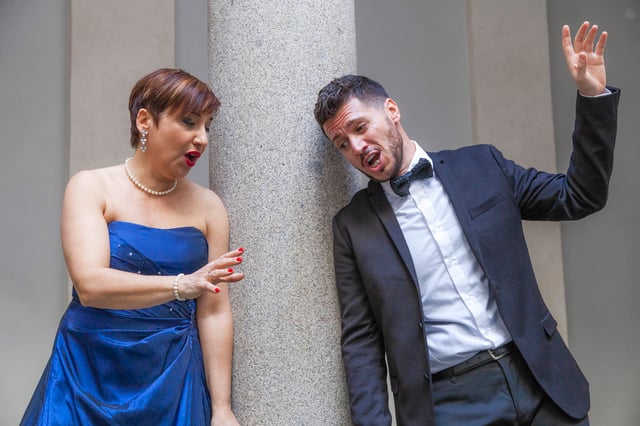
xmin=315 ymin=22 xmax=619 ymax=426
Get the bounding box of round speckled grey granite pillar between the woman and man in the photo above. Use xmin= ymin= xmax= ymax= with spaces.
xmin=209 ymin=0 xmax=361 ymax=426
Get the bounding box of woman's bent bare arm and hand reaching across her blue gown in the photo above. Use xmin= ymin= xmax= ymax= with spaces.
xmin=61 ymin=169 xmax=226 ymax=309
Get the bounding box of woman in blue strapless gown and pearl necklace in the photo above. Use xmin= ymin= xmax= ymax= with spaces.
xmin=21 ymin=69 xmax=244 ymax=425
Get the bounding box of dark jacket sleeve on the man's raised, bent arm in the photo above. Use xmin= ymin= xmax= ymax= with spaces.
xmin=493 ymin=87 xmax=620 ymax=220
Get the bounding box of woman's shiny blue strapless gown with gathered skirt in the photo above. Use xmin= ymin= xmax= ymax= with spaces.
xmin=21 ymin=222 xmax=211 ymax=426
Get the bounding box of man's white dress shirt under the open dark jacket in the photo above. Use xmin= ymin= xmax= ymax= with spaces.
xmin=382 ymin=142 xmax=512 ymax=373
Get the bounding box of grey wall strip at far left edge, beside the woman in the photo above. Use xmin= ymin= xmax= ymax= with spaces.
xmin=0 ymin=0 xmax=69 ymax=425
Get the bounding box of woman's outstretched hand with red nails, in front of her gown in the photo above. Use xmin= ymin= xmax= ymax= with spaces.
xmin=178 ymin=248 xmax=245 ymax=299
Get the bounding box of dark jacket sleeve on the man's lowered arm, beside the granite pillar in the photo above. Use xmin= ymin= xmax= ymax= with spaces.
xmin=333 ymin=217 xmax=391 ymax=426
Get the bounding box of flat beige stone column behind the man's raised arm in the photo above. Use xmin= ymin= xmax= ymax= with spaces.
xmin=467 ymin=0 xmax=571 ymax=338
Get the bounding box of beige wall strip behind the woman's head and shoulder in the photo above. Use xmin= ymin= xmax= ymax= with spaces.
xmin=69 ymin=0 xmax=175 ymax=174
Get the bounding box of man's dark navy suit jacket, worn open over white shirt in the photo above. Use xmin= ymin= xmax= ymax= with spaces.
xmin=333 ymin=87 xmax=620 ymax=426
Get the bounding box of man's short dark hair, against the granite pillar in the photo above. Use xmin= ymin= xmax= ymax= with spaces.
xmin=313 ymin=74 xmax=389 ymax=127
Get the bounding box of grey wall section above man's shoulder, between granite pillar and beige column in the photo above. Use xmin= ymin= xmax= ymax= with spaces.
xmin=355 ymin=0 xmax=472 ymax=150
